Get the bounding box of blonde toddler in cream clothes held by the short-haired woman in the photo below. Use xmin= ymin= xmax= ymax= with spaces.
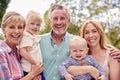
xmin=20 ymin=11 xmax=42 ymax=79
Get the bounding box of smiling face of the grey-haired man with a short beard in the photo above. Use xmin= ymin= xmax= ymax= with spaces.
xmin=50 ymin=9 xmax=70 ymax=35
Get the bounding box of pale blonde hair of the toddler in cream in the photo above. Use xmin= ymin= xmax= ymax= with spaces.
xmin=26 ymin=10 xmax=42 ymax=24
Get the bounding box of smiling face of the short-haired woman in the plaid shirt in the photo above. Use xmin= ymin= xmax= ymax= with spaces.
xmin=2 ymin=22 xmax=24 ymax=45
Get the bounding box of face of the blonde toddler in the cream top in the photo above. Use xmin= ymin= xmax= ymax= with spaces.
xmin=26 ymin=20 xmax=41 ymax=34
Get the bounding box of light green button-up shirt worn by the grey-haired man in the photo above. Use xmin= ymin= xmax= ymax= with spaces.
xmin=40 ymin=33 xmax=73 ymax=80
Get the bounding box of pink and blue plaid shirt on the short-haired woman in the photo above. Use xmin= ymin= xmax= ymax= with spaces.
xmin=0 ymin=41 xmax=23 ymax=80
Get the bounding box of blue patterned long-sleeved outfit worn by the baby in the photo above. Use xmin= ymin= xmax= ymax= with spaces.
xmin=59 ymin=55 xmax=105 ymax=80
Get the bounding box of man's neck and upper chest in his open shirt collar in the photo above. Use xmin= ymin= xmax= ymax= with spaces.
xmin=52 ymin=32 xmax=65 ymax=46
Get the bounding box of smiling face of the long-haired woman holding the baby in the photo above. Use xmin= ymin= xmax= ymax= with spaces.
xmin=83 ymin=23 xmax=100 ymax=47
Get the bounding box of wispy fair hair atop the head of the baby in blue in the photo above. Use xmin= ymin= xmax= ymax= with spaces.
xmin=69 ymin=36 xmax=88 ymax=48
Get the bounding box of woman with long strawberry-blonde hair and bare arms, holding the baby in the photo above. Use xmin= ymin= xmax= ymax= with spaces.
xmin=68 ymin=20 xmax=120 ymax=80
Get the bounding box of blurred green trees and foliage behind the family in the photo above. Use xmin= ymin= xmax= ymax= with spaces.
xmin=0 ymin=0 xmax=120 ymax=49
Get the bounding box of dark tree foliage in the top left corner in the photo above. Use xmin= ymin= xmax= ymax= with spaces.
xmin=0 ymin=0 xmax=10 ymax=25
